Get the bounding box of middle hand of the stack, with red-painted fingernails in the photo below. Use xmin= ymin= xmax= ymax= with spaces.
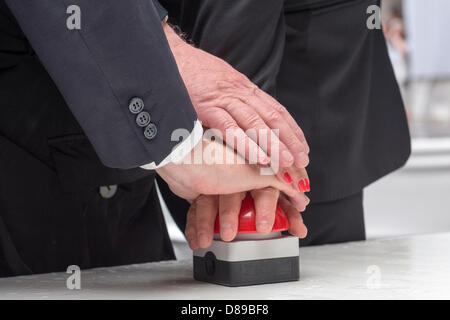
xmin=156 ymin=140 xmax=309 ymax=210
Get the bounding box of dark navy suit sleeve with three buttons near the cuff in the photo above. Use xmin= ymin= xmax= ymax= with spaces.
xmin=6 ymin=0 xmax=197 ymax=169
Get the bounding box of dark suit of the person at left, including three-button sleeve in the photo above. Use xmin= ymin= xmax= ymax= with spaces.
xmin=0 ymin=0 xmax=190 ymax=277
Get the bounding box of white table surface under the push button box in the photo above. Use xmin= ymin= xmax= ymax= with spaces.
xmin=0 ymin=233 xmax=450 ymax=299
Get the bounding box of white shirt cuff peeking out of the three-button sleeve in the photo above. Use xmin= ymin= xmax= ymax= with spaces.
xmin=141 ymin=120 xmax=203 ymax=170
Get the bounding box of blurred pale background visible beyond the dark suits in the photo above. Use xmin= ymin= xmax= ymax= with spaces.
xmin=163 ymin=0 xmax=450 ymax=258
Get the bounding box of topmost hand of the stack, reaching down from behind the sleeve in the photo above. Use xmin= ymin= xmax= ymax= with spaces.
xmin=163 ymin=24 xmax=309 ymax=174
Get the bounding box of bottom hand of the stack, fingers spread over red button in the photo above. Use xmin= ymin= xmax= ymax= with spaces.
xmin=185 ymin=188 xmax=307 ymax=250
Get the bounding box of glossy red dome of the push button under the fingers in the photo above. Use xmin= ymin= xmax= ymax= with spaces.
xmin=214 ymin=193 xmax=289 ymax=233
